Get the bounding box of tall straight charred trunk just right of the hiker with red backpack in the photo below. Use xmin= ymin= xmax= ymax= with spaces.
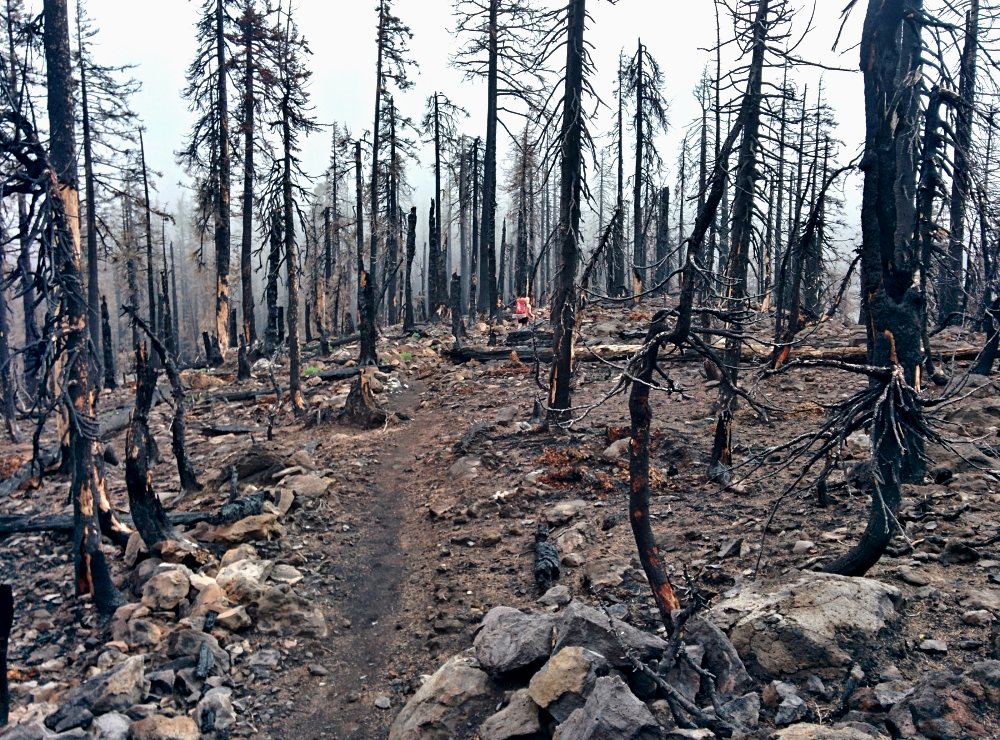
xmin=549 ymin=0 xmax=587 ymax=423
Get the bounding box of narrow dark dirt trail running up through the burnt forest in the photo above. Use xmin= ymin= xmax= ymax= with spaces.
xmin=260 ymin=386 xmax=435 ymax=740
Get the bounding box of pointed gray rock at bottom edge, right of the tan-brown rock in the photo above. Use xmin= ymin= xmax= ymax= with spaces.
xmin=553 ymin=676 xmax=661 ymax=740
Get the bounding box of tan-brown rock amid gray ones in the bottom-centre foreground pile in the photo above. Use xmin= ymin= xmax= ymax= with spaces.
xmin=528 ymin=646 xmax=608 ymax=722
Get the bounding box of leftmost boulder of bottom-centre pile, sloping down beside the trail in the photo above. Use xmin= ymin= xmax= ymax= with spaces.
xmin=389 ymin=650 xmax=496 ymax=740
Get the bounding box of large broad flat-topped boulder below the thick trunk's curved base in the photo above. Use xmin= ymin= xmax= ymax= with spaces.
xmin=709 ymin=573 xmax=901 ymax=676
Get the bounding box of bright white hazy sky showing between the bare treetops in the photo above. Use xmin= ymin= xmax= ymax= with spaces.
xmin=74 ymin=0 xmax=863 ymax=247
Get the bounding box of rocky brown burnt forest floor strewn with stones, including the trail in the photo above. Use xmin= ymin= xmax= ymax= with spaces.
xmin=0 ymin=308 xmax=1000 ymax=738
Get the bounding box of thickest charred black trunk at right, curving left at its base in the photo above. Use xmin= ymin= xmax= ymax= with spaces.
xmin=826 ymin=0 xmax=924 ymax=575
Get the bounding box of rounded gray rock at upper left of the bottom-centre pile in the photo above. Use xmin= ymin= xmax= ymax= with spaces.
xmin=473 ymin=606 xmax=555 ymax=674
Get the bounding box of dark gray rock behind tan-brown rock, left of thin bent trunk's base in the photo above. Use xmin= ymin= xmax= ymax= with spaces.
xmin=553 ymin=601 xmax=667 ymax=668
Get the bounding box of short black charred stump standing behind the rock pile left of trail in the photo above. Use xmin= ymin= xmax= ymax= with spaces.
xmin=125 ymin=342 xmax=176 ymax=550
